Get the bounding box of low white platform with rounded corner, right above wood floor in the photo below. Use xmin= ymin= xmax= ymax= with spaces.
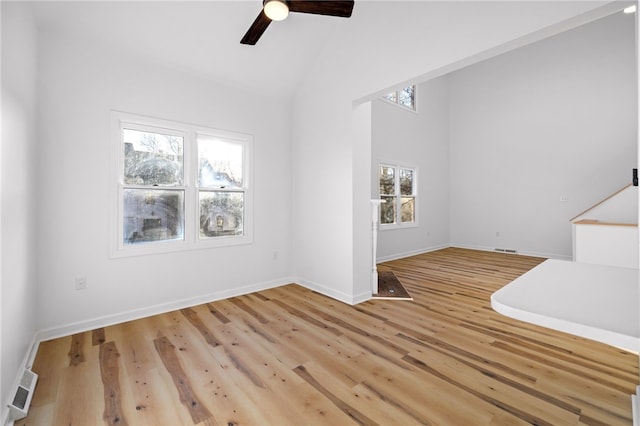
xmin=491 ymin=259 xmax=640 ymax=353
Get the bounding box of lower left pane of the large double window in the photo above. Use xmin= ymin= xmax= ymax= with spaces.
xmin=123 ymin=189 xmax=184 ymax=244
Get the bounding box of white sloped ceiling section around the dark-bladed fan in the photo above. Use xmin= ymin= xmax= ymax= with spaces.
xmin=35 ymin=0 xmax=356 ymax=97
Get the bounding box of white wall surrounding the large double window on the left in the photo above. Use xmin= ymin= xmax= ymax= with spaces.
xmin=37 ymin=32 xmax=291 ymax=335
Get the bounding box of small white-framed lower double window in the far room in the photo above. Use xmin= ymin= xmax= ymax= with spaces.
xmin=378 ymin=163 xmax=418 ymax=229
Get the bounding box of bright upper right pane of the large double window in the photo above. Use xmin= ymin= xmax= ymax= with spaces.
xmin=198 ymin=135 xmax=243 ymax=188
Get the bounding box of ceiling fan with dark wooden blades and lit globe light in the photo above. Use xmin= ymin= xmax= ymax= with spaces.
xmin=240 ymin=0 xmax=353 ymax=45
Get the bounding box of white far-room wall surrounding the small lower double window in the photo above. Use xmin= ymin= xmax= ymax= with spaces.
xmin=371 ymin=77 xmax=449 ymax=261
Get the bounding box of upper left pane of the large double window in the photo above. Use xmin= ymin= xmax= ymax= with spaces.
xmin=123 ymin=129 xmax=184 ymax=186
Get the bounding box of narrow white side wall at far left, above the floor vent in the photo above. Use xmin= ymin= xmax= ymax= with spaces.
xmin=0 ymin=2 xmax=38 ymax=416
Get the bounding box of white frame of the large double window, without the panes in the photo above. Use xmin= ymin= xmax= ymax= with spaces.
xmin=109 ymin=111 xmax=253 ymax=258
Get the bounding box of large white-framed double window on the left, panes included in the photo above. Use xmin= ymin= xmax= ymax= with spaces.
xmin=111 ymin=112 xmax=253 ymax=257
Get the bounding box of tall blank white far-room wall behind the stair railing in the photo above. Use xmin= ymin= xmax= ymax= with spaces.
xmin=450 ymin=13 xmax=637 ymax=259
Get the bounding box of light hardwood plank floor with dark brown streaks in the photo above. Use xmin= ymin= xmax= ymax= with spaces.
xmin=17 ymin=248 xmax=638 ymax=426
